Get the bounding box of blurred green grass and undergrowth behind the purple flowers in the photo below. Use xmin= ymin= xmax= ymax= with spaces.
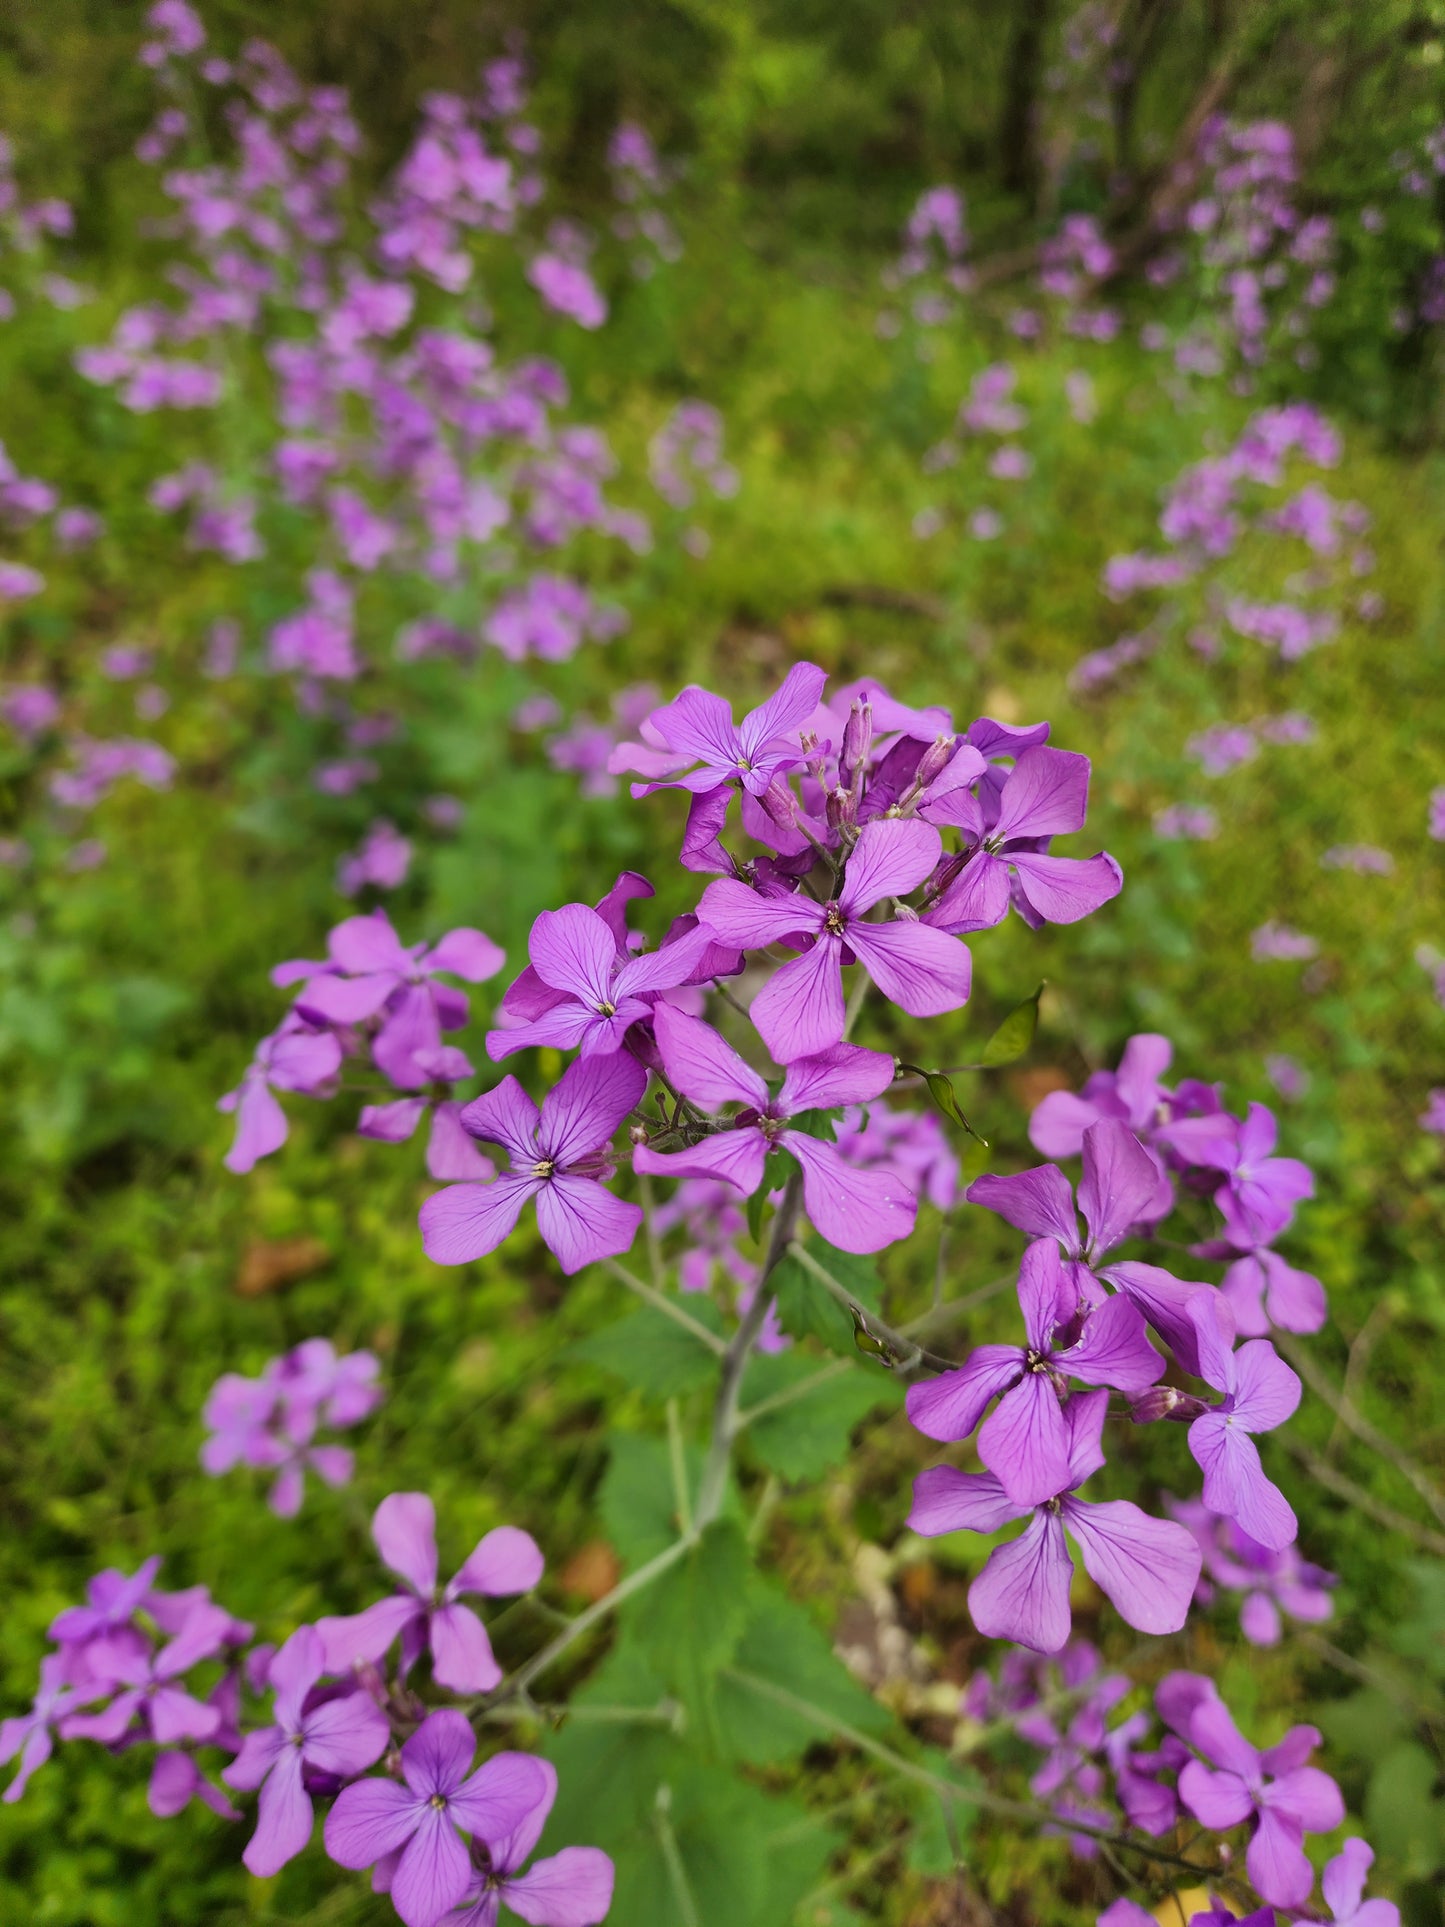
xmin=0 ymin=0 xmax=1445 ymax=1927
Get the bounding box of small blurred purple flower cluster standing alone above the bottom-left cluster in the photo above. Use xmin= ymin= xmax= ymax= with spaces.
xmin=200 ymin=1337 xmax=383 ymax=1518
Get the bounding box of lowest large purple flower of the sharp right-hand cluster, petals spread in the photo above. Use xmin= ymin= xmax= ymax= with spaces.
xmin=907 ymin=1391 xmax=1200 ymax=1653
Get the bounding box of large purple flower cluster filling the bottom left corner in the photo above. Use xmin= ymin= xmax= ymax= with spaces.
xmin=0 ymin=1487 xmax=613 ymax=1927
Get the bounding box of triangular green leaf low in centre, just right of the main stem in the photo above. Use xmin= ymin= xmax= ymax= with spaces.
xmin=717 ymin=1582 xmax=894 ymax=1767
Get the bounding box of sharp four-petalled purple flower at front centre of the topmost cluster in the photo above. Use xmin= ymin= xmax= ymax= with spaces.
xmin=697 ymin=817 xmax=971 ymax=1064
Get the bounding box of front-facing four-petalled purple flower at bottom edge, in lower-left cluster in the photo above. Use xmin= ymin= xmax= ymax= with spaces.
xmin=326 ymin=1707 xmax=549 ymax=1927
